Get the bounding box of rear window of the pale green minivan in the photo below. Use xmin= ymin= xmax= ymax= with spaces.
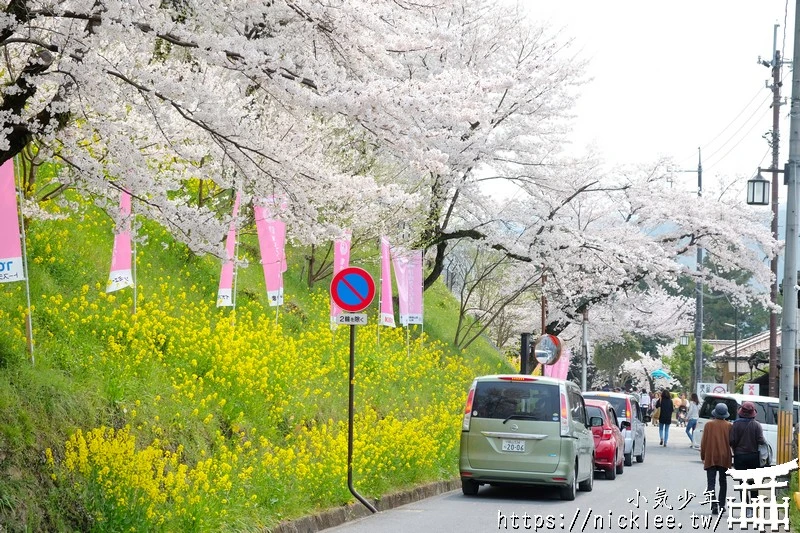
xmin=472 ymin=381 xmax=559 ymax=422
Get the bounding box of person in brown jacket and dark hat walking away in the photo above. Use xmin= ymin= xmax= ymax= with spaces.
xmin=692 ymin=404 xmax=732 ymax=514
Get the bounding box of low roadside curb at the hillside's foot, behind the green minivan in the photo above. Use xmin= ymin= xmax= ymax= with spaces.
xmin=267 ymin=478 xmax=461 ymax=533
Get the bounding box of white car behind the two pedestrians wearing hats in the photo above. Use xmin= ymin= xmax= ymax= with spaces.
xmin=694 ymin=393 xmax=800 ymax=465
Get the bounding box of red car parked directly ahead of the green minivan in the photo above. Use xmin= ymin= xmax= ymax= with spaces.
xmin=586 ymin=399 xmax=630 ymax=479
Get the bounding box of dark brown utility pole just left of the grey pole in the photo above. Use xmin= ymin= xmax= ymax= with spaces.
xmin=767 ymin=24 xmax=781 ymax=397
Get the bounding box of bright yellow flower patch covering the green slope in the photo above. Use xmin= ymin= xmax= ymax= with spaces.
xmin=0 ymin=203 xmax=504 ymax=531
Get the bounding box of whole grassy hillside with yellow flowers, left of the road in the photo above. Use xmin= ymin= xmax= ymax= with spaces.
xmin=0 ymin=195 xmax=511 ymax=531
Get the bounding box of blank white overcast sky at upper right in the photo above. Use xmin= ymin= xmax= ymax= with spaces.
xmin=525 ymin=0 xmax=794 ymax=201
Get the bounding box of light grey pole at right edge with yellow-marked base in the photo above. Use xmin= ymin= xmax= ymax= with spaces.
xmin=778 ymin=0 xmax=800 ymax=464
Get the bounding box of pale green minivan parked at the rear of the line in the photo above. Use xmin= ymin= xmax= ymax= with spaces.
xmin=459 ymin=375 xmax=595 ymax=500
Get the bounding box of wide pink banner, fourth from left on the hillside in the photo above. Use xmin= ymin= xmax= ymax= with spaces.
xmin=253 ymin=201 xmax=286 ymax=307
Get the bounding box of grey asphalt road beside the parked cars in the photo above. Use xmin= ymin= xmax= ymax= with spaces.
xmin=327 ymin=426 xmax=784 ymax=533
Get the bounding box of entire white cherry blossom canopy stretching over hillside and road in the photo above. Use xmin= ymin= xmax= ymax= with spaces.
xmin=0 ymin=0 xmax=778 ymax=337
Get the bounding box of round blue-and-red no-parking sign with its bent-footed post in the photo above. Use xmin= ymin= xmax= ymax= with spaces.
xmin=331 ymin=267 xmax=378 ymax=513
